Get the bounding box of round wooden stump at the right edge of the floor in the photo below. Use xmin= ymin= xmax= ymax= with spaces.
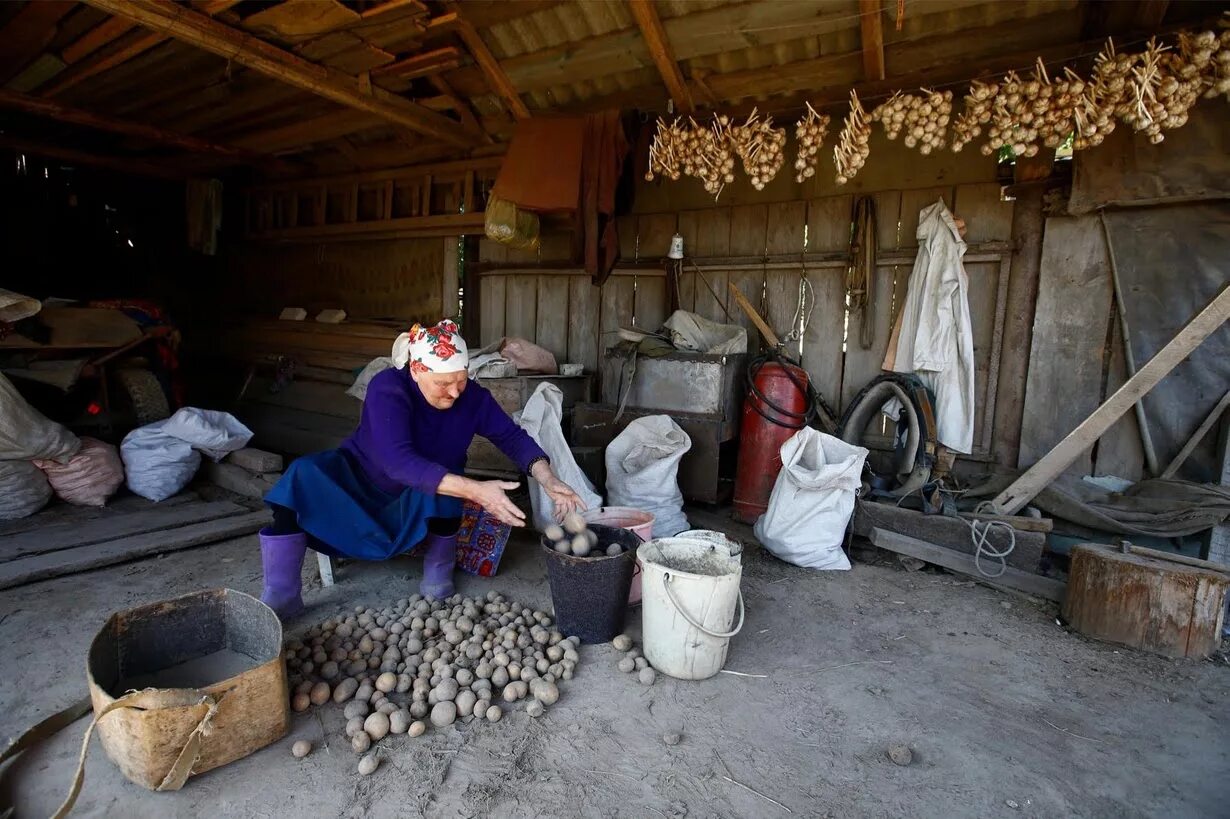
xmin=1063 ymin=544 xmax=1230 ymax=658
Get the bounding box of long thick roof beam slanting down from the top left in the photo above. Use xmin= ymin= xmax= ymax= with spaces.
xmin=86 ymin=0 xmax=477 ymax=148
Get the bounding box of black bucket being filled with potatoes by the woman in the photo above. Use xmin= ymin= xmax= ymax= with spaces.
xmin=541 ymin=524 xmax=641 ymax=643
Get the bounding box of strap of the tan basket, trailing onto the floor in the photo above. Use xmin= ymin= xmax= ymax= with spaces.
xmin=0 ymin=689 xmax=223 ymax=819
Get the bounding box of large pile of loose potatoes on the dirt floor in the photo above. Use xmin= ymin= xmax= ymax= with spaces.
xmin=283 ymin=592 xmax=581 ymax=774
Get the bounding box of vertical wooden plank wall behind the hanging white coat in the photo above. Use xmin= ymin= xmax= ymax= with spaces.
xmin=480 ymin=182 xmax=1027 ymax=460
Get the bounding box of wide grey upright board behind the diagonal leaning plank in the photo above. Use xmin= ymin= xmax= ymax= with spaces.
xmin=1018 ymin=216 xmax=1112 ymax=476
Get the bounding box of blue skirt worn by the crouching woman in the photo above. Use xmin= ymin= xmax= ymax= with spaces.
xmin=264 ymin=449 xmax=461 ymax=561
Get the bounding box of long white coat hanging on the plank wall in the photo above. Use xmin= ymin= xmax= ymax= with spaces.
xmin=884 ymin=199 xmax=974 ymax=454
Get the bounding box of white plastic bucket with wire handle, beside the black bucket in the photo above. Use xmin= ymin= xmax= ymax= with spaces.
xmin=636 ymin=537 xmax=744 ymax=680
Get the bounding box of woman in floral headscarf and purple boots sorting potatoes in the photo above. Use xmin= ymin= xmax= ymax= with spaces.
xmin=261 ymin=321 xmax=583 ymax=617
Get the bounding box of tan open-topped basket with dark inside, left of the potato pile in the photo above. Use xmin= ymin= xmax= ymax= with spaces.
xmin=87 ymin=589 xmax=290 ymax=791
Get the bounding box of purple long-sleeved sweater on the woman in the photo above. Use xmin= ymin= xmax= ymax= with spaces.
xmin=342 ymin=369 xmax=546 ymax=494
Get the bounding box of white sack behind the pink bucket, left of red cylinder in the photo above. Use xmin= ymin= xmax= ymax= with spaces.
xmin=606 ymin=416 xmax=691 ymax=537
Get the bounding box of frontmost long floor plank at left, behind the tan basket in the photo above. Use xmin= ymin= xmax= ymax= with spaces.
xmin=0 ymin=510 xmax=269 ymax=589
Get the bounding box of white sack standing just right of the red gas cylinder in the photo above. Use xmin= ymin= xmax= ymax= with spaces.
xmin=754 ymin=427 xmax=867 ymax=571
